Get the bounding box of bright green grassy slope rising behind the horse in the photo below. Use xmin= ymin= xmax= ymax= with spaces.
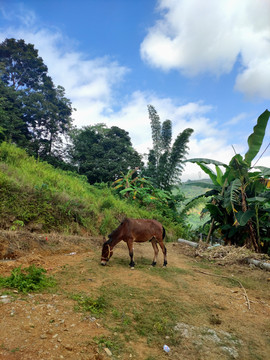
xmin=0 ymin=143 xmax=182 ymax=238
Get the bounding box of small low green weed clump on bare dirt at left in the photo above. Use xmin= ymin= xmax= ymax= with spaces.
xmin=0 ymin=265 xmax=55 ymax=293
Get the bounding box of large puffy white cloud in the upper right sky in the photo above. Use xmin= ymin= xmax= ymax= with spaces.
xmin=141 ymin=0 xmax=270 ymax=99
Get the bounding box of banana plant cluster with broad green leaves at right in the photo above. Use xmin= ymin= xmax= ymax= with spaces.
xmin=188 ymin=110 xmax=270 ymax=252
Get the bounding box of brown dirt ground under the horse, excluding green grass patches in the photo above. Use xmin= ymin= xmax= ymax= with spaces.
xmin=0 ymin=234 xmax=270 ymax=360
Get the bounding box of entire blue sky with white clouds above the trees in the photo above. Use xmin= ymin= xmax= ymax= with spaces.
xmin=0 ymin=0 xmax=270 ymax=181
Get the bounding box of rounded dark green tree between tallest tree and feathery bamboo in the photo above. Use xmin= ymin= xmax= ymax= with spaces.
xmin=70 ymin=124 xmax=143 ymax=184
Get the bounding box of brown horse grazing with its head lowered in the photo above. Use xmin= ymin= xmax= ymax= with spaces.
xmin=101 ymin=219 xmax=167 ymax=269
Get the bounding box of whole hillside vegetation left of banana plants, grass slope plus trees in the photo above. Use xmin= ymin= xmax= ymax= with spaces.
xmin=0 ymin=39 xmax=196 ymax=242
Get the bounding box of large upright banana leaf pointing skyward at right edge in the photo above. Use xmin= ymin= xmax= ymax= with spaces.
xmin=245 ymin=110 xmax=270 ymax=166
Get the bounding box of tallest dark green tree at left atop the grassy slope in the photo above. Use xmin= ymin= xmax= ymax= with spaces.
xmin=0 ymin=39 xmax=72 ymax=160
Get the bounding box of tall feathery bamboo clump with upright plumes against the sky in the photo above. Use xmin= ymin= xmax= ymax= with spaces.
xmin=145 ymin=105 xmax=193 ymax=191
